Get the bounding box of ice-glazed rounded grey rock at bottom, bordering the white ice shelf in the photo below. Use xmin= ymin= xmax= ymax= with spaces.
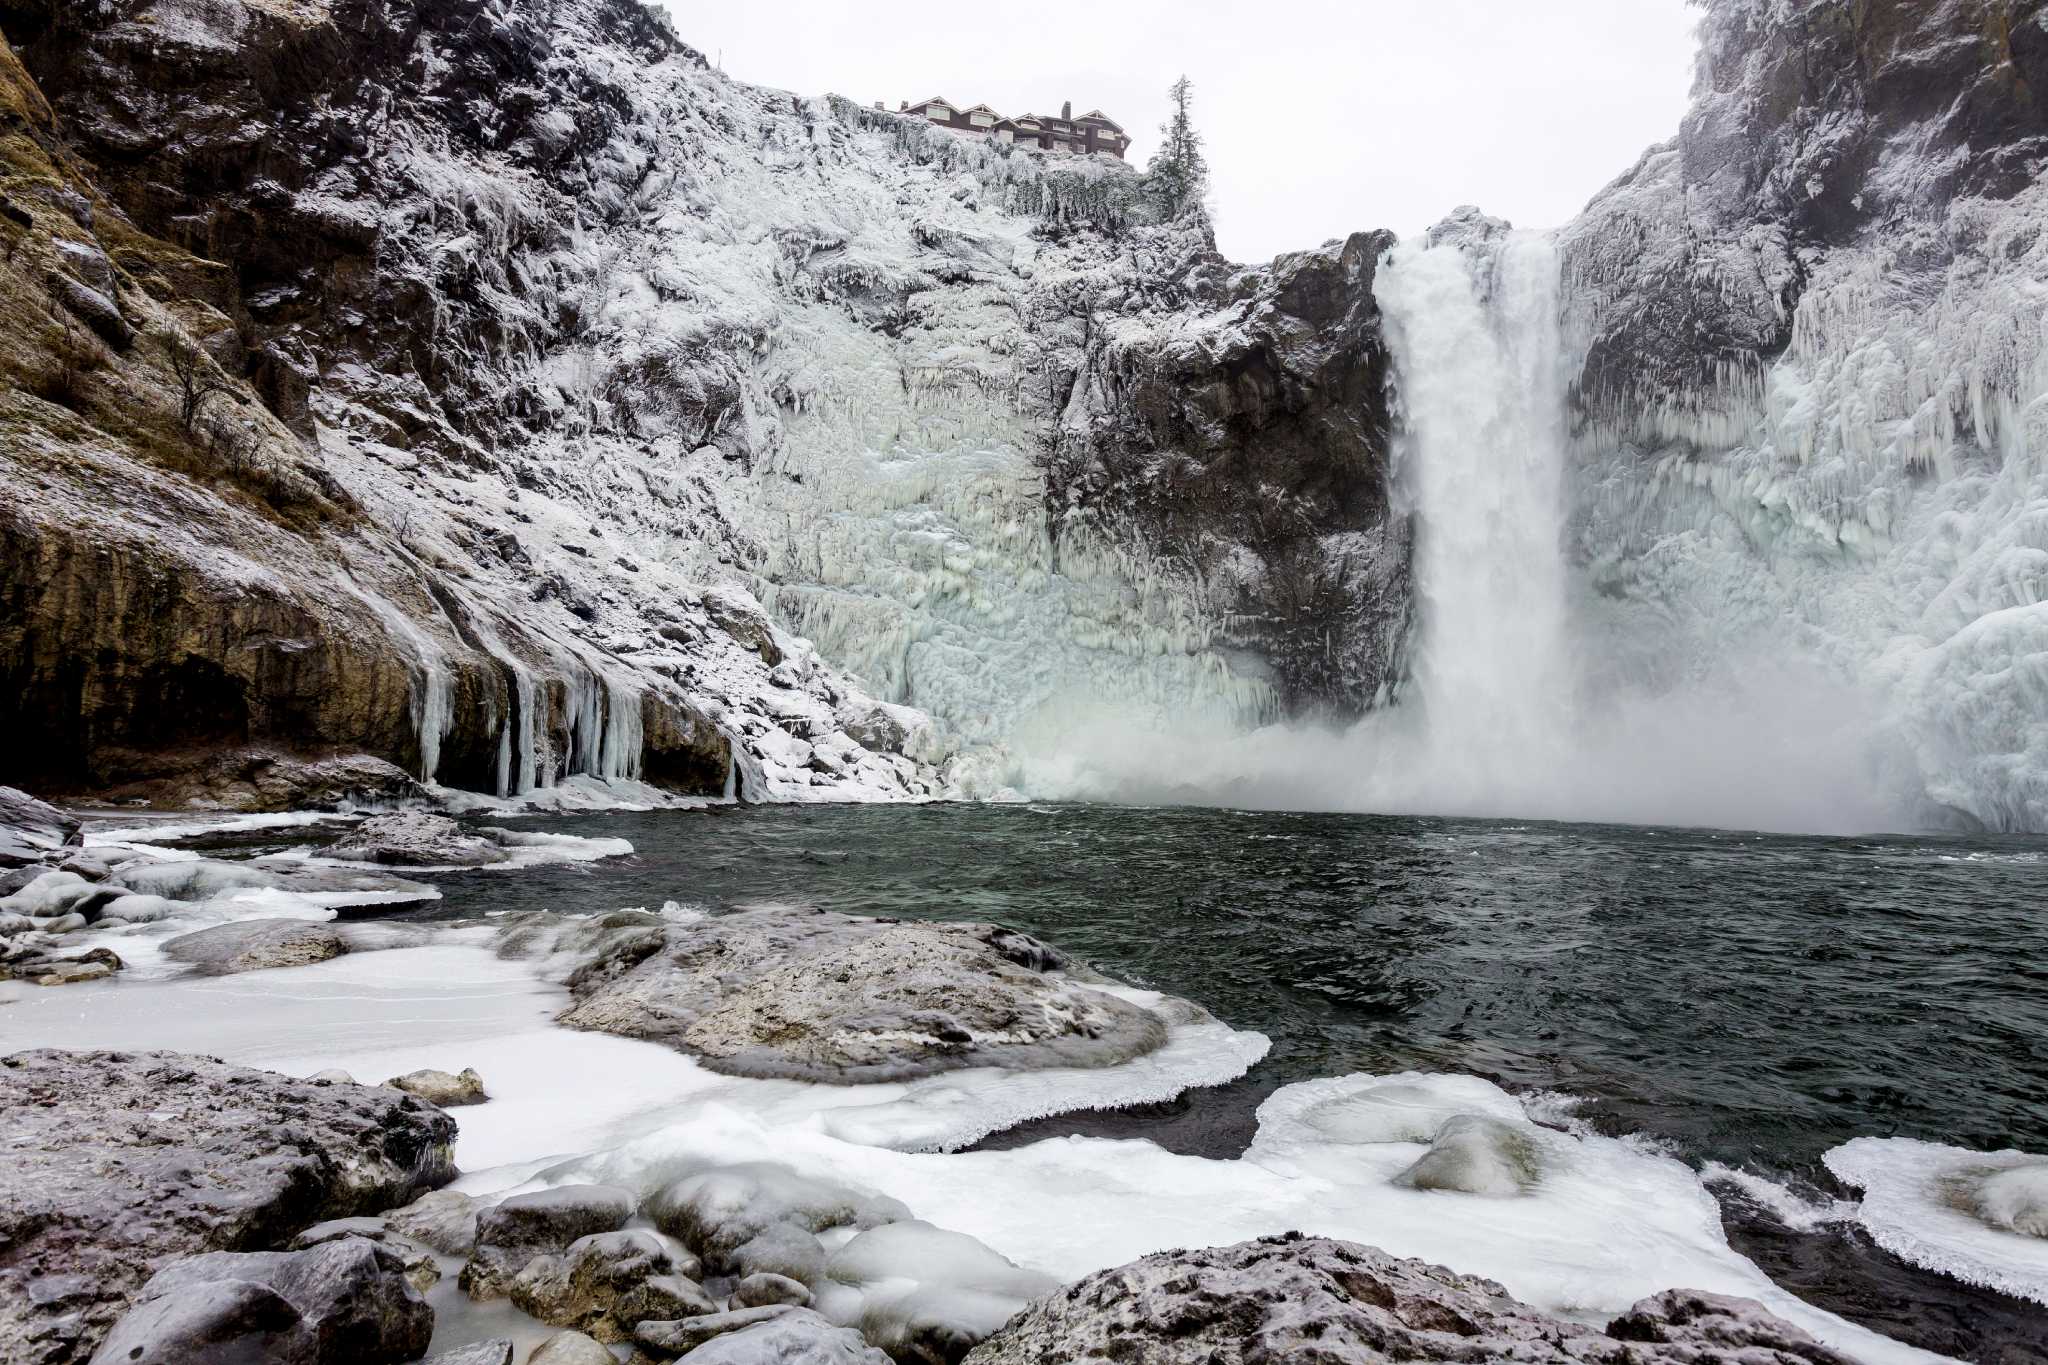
xmin=641 ymin=1162 xmax=909 ymax=1283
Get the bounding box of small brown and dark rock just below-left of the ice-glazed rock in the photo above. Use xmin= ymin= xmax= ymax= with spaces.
xmin=510 ymin=1228 xmax=719 ymax=1342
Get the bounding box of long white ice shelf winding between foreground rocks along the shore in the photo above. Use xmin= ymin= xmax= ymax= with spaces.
xmin=0 ymin=927 xmax=1966 ymax=1361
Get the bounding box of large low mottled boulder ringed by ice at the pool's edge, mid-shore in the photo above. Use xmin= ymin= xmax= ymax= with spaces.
xmin=561 ymin=911 xmax=1200 ymax=1083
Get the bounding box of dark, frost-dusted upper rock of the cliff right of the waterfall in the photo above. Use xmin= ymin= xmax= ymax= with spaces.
xmin=1565 ymin=0 xmax=2048 ymax=442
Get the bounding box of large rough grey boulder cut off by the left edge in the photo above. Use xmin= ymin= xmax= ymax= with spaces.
xmin=0 ymin=1050 xmax=455 ymax=1365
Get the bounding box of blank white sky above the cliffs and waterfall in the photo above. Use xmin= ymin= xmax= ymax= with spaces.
xmin=664 ymin=0 xmax=1694 ymax=262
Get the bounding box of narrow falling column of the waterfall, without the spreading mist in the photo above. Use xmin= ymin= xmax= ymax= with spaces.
xmin=1374 ymin=233 xmax=1573 ymax=810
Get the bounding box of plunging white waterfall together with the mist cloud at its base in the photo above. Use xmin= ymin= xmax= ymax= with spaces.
xmin=1056 ymin=227 xmax=1907 ymax=831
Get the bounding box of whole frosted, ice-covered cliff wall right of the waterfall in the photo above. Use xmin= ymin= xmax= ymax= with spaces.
xmin=1561 ymin=0 xmax=2048 ymax=829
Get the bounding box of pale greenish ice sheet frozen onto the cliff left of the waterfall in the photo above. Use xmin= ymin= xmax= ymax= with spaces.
xmin=748 ymin=319 xmax=1274 ymax=796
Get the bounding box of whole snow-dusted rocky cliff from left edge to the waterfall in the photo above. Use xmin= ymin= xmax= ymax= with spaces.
xmin=0 ymin=0 xmax=1405 ymax=804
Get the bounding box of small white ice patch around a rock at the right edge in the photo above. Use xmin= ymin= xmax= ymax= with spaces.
xmin=1823 ymin=1138 xmax=2048 ymax=1304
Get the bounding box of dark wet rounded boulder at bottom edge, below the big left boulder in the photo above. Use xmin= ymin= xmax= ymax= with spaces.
xmin=92 ymin=1238 xmax=434 ymax=1365
